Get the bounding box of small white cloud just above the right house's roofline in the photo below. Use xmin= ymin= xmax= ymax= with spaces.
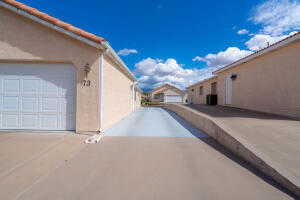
xmin=245 ymin=31 xmax=297 ymax=51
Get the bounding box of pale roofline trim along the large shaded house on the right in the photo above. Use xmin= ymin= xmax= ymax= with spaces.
xmin=213 ymin=33 xmax=300 ymax=74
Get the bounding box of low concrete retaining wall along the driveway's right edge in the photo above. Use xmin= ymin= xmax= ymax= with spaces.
xmin=166 ymin=104 xmax=300 ymax=196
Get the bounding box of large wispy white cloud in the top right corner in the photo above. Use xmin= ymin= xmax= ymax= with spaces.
xmin=250 ymin=0 xmax=300 ymax=36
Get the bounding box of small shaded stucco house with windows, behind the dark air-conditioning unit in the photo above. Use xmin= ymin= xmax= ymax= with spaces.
xmin=187 ymin=76 xmax=218 ymax=104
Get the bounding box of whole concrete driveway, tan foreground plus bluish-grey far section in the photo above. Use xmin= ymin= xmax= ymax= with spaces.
xmin=0 ymin=108 xmax=293 ymax=200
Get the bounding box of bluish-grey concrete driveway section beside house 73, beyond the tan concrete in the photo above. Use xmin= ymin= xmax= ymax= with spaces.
xmin=105 ymin=107 xmax=208 ymax=138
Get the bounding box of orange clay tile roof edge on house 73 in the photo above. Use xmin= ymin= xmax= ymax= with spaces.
xmin=1 ymin=0 xmax=105 ymax=43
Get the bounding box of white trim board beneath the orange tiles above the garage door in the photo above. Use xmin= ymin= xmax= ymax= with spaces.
xmin=0 ymin=1 xmax=103 ymax=49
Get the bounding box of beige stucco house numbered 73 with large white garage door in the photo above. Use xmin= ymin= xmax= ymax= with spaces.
xmin=0 ymin=0 xmax=139 ymax=133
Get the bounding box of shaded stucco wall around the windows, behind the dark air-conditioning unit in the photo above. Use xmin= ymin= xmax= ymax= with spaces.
xmin=188 ymin=77 xmax=219 ymax=104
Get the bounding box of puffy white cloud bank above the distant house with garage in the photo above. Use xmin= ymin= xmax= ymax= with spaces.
xmin=135 ymin=58 xmax=215 ymax=89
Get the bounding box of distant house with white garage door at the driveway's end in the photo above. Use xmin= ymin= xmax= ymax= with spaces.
xmin=150 ymin=84 xmax=186 ymax=103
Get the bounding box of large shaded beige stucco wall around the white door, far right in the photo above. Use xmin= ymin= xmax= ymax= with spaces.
xmin=218 ymin=41 xmax=300 ymax=117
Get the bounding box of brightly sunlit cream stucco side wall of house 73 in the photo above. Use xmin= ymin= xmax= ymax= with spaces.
xmin=102 ymin=56 xmax=134 ymax=130
